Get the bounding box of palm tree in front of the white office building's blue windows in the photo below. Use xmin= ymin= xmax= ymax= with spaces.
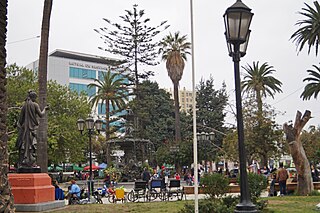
xmin=88 ymin=69 xmax=129 ymax=163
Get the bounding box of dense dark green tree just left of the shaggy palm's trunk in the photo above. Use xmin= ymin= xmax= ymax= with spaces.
xmin=129 ymin=80 xmax=174 ymax=149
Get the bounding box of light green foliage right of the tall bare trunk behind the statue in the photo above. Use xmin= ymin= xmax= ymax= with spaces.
xmin=47 ymin=81 xmax=91 ymax=163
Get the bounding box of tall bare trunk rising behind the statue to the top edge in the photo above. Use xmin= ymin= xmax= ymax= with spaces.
xmin=37 ymin=0 xmax=53 ymax=172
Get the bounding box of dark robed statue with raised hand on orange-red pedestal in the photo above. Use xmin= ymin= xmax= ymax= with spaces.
xmin=16 ymin=90 xmax=49 ymax=168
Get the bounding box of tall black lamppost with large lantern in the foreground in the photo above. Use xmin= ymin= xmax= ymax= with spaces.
xmin=224 ymin=0 xmax=256 ymax=212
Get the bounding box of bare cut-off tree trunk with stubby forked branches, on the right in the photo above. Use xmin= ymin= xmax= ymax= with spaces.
xmin=283 ymin=110 xmax=313 ymax=195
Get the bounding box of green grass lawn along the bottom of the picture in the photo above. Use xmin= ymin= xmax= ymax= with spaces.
xmin=50 ymin=196 xmax=320 ymax=213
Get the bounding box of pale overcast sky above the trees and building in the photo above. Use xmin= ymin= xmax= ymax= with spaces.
xmin=6 ymin=0 xmax=320 ymax=127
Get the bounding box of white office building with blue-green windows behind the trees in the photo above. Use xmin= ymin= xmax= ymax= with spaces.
xmin=26 ymin=50 xmax=123 ymax=115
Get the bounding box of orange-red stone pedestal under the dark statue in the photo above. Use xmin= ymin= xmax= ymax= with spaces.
xmin=8 ymin=173 xmax=64 ymax=211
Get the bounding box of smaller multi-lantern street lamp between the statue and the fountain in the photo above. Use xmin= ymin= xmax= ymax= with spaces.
xmin=77 ymin=117 xmax=103 ymax=202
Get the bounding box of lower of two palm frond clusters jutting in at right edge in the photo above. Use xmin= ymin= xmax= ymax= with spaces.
xmin=300 ymin=65 xmax=320 ymax=100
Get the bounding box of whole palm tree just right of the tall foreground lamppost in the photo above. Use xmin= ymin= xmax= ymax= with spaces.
xmin=242 ymin=62 xmax=282 ymax=166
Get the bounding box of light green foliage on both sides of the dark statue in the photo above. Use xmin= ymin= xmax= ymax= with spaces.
xmin=6 ymin=64 xmax=91 ymax=164
